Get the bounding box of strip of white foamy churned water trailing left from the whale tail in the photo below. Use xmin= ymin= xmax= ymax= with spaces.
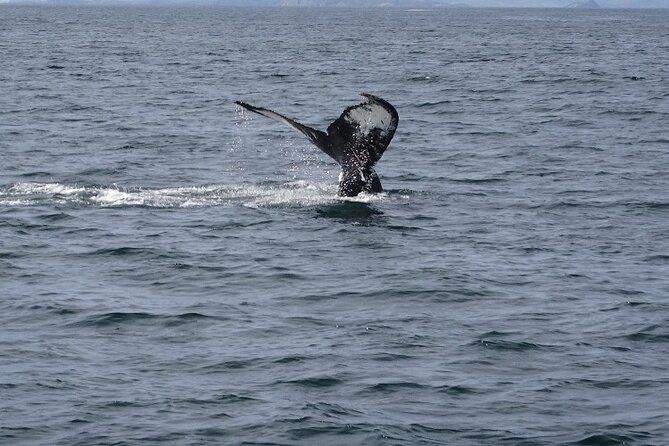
xmin=0 ymin=180 xmax=394 ymax=208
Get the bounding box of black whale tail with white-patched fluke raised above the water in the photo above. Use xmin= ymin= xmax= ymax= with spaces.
xmin=235 ymin=93 xmax=399 ymax=197
